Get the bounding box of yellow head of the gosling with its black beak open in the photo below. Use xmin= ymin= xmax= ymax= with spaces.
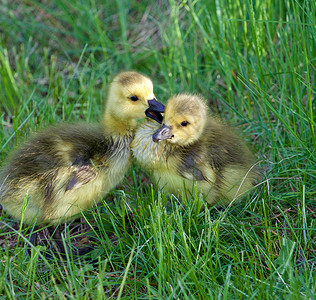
xmin=105 ymin=71 xmax=164 ymax=126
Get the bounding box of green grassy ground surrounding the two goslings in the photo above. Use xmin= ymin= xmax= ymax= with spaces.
xmin=0 ymin=0 xmax=316 ymax=299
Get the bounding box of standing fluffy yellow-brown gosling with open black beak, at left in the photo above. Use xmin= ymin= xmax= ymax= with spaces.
xmin=0 ymin=71 xmax=164 ymax=224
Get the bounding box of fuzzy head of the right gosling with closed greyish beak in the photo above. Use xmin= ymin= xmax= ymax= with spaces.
xmin=153 ymin=94 xmax=208 ymax=146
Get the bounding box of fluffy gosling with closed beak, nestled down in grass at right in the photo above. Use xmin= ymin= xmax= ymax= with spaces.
xmin=132 ymin=94 xmax=259 ymax=205
